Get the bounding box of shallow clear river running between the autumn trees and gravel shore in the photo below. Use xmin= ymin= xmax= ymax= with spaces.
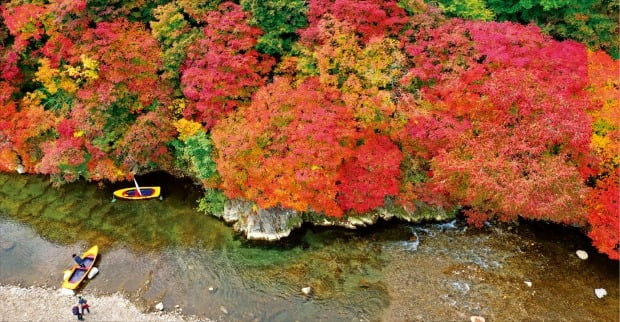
xmin=0 ymin=173 xmax=619 ymax=321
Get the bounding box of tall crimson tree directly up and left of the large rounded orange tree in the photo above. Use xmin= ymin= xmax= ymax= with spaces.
xmin=181 ymin=3 xmax=274 ymax=128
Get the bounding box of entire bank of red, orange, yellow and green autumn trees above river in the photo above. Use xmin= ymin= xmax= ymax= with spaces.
xmin=0 ymin=0 xmax=620 ymax=259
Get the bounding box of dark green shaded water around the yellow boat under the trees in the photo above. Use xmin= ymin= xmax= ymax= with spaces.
xmin=0 ymin=171 xmax=237 ymax=251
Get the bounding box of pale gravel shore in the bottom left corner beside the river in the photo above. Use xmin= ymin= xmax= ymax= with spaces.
xmin=0 ymin=285 xmax=211 ymax=322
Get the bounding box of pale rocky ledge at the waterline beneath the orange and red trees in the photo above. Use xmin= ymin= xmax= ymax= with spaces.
xmin=215 ymin=199 xmax=456 ymax=241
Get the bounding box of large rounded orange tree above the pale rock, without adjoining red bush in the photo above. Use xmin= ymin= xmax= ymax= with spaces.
xmin=212 ymin=78 xmax=358 ymax=216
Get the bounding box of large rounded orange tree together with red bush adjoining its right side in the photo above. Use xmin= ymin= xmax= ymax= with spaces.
xmin=212 ymin=77 xmax=402 ymax=217
